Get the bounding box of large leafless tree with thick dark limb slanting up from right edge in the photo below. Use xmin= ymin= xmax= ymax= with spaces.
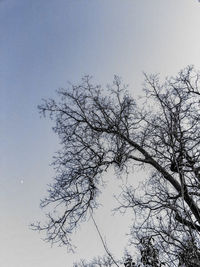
xmin=35 ymin=66 xmax=200 ymax=266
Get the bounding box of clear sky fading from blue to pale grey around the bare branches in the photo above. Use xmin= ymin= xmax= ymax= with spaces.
xmin=0 ymin=0 xmax=200 ymax=267
